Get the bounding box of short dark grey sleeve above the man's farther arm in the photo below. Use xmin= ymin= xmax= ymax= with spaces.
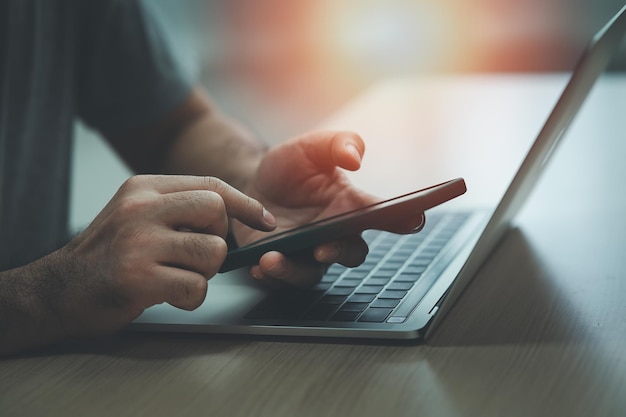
xmin=77 ymin=0 xmax=191 ymax=135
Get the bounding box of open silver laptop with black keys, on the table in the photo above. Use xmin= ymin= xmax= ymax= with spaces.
xmin=129 ymin=6 xmax=626 ymax=340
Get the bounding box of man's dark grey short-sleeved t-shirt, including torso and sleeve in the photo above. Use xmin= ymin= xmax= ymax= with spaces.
xmin=0 ymin=0 xmax=190 ymax=271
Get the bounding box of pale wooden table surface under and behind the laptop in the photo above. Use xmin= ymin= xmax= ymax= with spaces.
xmin=0 ymin=74 xmax=626 ymax=416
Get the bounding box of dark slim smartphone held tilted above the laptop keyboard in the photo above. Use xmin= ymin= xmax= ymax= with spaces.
xmin=220 ymin=178 xmax=467 ymax=272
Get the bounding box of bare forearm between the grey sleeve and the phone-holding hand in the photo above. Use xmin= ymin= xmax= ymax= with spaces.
xmin=108 ymin=89 xmax=265 ymax=189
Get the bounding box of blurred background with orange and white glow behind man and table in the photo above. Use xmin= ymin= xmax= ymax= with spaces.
xmin=72 ymin=0 xmax=626 ymax=228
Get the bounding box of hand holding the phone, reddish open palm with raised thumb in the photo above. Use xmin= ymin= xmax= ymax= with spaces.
xmin=233 ymin=132 xmax=423 ymax=286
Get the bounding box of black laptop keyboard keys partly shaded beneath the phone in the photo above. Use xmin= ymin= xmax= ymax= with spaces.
xmin=245 ymin=213 xmax=468 ymax=325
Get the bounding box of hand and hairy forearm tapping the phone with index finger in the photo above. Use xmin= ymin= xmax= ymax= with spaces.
xmin=0 ymin=176 xmax=275 ymax=352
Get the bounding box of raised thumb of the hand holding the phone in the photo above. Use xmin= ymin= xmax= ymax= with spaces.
xmin=299 ymin=132 xmax=365 ymax=171
